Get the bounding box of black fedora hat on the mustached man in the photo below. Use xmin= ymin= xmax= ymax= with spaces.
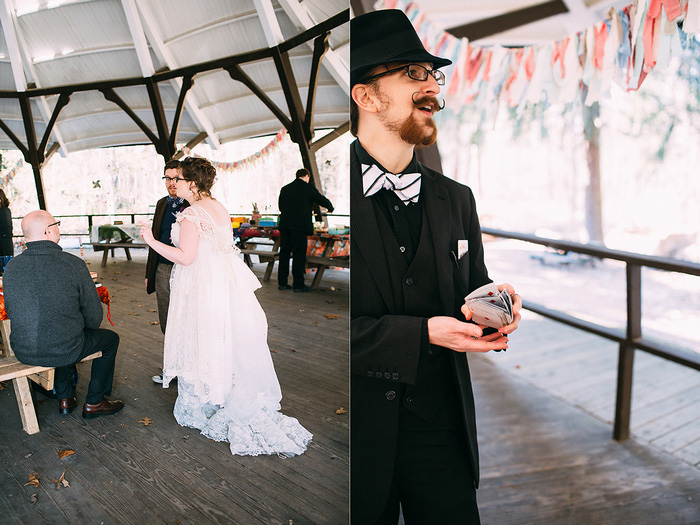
xmin=350 ymin=9 xmax=452 ymax=86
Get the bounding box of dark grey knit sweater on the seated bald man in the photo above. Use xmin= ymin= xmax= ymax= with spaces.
xmin=3 ymin=241 xmax=102 ymax=366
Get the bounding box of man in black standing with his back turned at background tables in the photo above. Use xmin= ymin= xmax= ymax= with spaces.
xmin=277 ymin=168 xmax=333 ymax=292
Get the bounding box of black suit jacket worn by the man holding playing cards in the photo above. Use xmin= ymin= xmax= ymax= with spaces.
xmin=350 ymin=141 xmax=491 ymax=523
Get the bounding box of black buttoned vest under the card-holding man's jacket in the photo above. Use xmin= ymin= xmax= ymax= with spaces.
xmin=374 ymin=201 xmax=463 ymax=429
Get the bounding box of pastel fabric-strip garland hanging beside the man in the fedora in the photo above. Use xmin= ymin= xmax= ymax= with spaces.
xmin=375 ymin=0 xmax=700 ymax=111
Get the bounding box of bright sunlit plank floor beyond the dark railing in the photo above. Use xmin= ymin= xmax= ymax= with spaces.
xmin=488 ymin=312 xmax=700 ymax=469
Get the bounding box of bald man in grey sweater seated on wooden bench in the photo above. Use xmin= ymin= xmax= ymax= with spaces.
xmin=3 ymin=210 xmax=124 ymax=419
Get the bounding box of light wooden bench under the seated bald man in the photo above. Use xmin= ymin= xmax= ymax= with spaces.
xmin=0 ymin=319 xmax=102 ymax=434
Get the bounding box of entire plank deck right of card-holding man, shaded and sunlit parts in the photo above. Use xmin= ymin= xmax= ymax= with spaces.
xmin=470 ymin=312 xmax=700 ymax=525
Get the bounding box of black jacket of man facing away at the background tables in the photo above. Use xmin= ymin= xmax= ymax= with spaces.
xmin=278 ymin=179 xmax=333 ymax=235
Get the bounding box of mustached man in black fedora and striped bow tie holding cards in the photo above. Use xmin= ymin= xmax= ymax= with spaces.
xmin=350 ymin=10 xmax=521 ymax=525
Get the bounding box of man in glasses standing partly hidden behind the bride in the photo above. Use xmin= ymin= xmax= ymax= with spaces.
xmin=146 ymin=160 xmax=190 ymax=384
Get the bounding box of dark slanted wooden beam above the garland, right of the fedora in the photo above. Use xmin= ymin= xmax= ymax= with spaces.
xmin=447 ymin=0 xmax=569 ymax=41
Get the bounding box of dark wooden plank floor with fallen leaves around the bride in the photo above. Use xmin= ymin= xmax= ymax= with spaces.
xmin=0 ymin=250 xmax=349 ymax=525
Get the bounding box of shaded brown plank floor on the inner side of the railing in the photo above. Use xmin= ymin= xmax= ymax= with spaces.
xmin=469 ymin=350 xmax=700 ymax=525
